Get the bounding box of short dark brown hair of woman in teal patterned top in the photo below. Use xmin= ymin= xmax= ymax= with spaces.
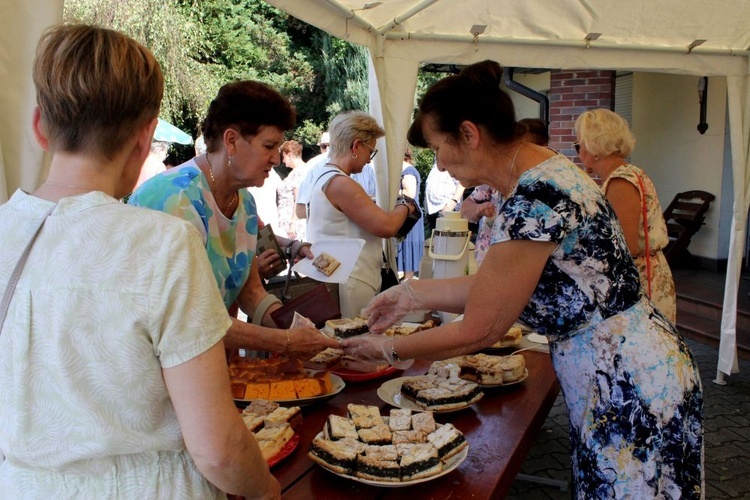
xmin=201 ymin=80 xmax=297 ymax=153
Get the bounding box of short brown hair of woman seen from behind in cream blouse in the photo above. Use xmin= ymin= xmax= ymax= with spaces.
xmin=33 ymin=24 xmax=164 ymax=159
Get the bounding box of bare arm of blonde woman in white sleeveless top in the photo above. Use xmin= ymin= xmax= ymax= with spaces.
xmin=325 ymin=175 xmax=411 ymax=238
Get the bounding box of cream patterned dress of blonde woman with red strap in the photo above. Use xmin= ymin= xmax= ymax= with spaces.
xmin=602 ymin=164 xmax=677 ymax=323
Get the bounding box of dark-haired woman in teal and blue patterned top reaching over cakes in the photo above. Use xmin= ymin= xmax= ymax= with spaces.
xmin=128 ymin=81 xmax=338 ymax=359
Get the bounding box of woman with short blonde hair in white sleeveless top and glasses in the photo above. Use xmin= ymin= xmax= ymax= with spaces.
xmin=307 ymin=111 xmax=416 ymax=318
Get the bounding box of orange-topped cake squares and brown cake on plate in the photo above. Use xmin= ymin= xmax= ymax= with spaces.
xmin=229 ymin=357 xmax=346 ymax=406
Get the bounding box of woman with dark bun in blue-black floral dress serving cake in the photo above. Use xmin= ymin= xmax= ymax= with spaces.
xmin=344 ymin=61 xmax=703 ymax=499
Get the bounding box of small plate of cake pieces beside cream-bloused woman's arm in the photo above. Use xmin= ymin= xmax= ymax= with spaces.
xmin=242 ymin=399 xmax=302 ymax=467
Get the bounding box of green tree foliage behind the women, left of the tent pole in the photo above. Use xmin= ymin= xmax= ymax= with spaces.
xmin=64 ymin=0 xmax=368 ymax=156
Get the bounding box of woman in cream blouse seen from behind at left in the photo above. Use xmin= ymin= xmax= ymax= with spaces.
xmin=0 ymin=25 xmax=280 ymax=498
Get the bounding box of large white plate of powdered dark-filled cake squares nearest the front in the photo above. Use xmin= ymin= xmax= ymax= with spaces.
xmin=308 ymin=404 xmax=469 ymax=487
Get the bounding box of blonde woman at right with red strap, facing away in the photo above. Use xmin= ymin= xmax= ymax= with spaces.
xmin=575 ymin=109 xmax=677 ymax=323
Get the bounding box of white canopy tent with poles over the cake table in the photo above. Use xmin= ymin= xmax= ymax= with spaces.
xmin=0 ymin=0 xmax=750 ymax=380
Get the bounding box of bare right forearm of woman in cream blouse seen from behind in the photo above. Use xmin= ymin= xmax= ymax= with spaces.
xmin=162 ymin=342 xmax=281 ymax=498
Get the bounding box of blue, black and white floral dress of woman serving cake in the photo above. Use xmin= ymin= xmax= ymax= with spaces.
xmin=492 ymin=156 xmax=703 ymax=499
